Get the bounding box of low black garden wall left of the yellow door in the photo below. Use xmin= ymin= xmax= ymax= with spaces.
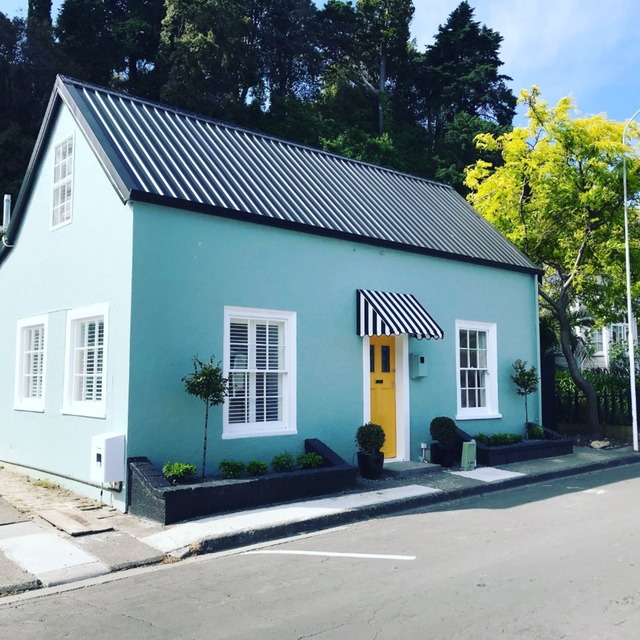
xmin=128 ymin=438 xmax=358 ymax=524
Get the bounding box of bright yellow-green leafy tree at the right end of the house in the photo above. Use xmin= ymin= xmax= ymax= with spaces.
xmin=467 ymin=87 xmax=640 ymax=436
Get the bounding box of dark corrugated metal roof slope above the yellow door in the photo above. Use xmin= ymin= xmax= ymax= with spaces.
xmin=1 ymin=77 xmax=538 ymax=271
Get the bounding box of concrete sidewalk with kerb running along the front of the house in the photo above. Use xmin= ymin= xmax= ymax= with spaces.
xmin=0 ymin=447 xmax=640 ymax=595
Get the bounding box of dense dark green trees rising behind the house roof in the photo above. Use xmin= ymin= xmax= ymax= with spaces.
xmin=0 ymin=0 xmax=516 ymax=197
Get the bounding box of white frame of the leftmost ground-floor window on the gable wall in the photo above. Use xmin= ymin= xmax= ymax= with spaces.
xmin=14 ymin=315 xmax=49 ymax=413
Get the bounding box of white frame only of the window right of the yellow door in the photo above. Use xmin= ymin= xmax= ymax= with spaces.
xmin=456 ymin=320 xmax=502 ymax=420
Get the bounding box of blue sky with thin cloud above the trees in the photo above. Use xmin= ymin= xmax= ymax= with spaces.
xmin=5 ymin=0 xmax=640 ymax=125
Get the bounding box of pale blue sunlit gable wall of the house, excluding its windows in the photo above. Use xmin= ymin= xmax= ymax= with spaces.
xmin=0 ymin=106 xmax=132 ymax=502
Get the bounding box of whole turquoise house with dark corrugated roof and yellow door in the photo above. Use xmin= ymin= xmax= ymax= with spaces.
xmin=0 ymin=78 xmax=540 ymax=509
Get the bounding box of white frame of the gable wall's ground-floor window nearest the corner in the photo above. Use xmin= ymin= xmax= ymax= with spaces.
xmin=62 ymin=304 xmax=109 ymax=418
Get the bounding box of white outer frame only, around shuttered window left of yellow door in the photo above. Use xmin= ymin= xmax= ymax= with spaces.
xmin=222 ymin=307 xmax=297 ymax=439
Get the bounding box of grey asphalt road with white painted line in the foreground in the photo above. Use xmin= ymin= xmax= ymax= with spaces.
xmin=0 ymin=465 xmax=640 ymax=640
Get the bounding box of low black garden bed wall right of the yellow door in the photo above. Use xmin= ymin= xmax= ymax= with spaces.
xmin=459 ymin=429 xmax=573 ymax=467
